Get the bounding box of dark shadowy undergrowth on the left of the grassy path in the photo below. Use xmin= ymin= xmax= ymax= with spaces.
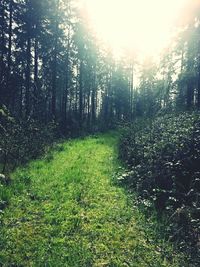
xmin=0 ymin=107 xmax=57 ymax=173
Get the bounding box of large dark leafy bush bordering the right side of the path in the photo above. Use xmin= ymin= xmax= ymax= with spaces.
xmin=119 ymin=113 xmax=200 ymax=260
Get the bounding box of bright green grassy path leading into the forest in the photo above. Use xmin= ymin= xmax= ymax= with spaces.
xmin=0 ymin=134 xmax=179 ymax=267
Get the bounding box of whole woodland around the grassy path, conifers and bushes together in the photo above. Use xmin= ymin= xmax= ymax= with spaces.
xmin=0 ymin=0 xmax=200 ymax=266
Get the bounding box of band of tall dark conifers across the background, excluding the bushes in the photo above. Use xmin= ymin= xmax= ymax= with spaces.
xmin=0 ymin=0 xmax=200 ymax=134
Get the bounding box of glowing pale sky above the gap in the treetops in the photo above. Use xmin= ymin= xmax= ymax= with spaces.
xmin=85 ymin=0 xmax=192 ymax=57
